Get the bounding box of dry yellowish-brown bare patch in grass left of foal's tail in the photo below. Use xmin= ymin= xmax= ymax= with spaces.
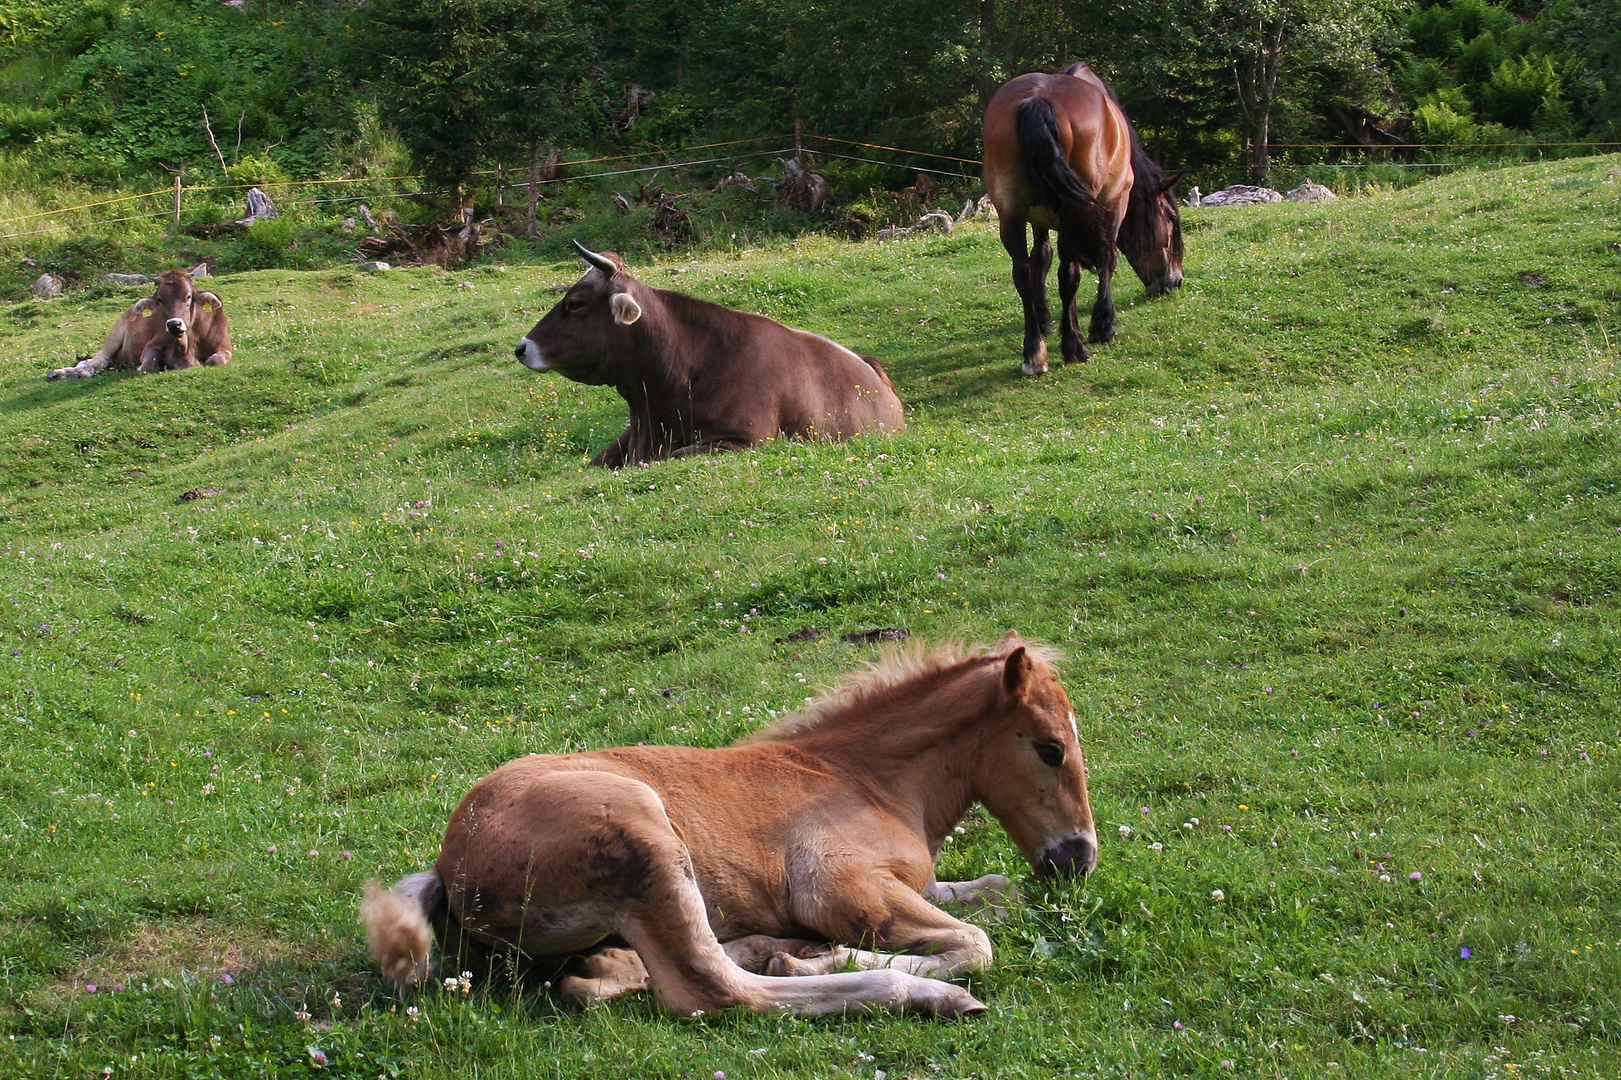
xmin=52 ymin=919 xmax=331 ymax=992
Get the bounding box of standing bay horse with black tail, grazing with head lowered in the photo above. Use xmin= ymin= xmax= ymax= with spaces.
xmin=986 ymin=63 xmax=1182 ymax=375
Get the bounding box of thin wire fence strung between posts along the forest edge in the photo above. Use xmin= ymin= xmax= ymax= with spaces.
xmin=0 ymin=131 xmax=1621 ymax=240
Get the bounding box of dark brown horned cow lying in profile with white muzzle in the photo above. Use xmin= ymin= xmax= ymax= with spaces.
xmin=517 ymin=243 xmax=906 ymax=469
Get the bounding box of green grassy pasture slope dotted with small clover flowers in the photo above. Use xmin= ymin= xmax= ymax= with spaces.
xmin=0 ymin=157 xmax=1621 ymax=1077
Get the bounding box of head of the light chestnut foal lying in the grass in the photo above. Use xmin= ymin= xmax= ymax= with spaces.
xmin=976 ymin=634 xmax=1097 ymax=877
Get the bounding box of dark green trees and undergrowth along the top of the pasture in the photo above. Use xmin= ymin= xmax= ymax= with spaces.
xmin=0 ymin=0 xmax=1621 ymax=191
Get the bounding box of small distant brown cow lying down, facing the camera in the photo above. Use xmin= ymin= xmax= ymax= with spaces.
xmin=45 ymin=271 xmax=230 ymax=379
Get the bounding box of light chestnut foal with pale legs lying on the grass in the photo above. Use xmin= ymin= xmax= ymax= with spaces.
xmin=361 ymin=634 xmax=1097 ymax=1017
